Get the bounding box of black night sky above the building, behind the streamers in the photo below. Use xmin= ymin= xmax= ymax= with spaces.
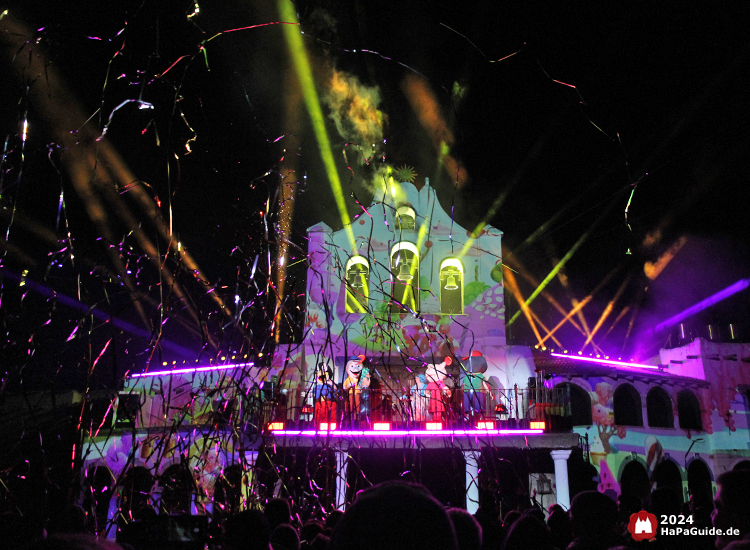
xmin=0 ymin=0 xmax=750 ymax=387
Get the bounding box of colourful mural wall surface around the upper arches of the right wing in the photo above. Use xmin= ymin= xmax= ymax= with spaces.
xmin=564 ymin=339 xmax=750 ymax=506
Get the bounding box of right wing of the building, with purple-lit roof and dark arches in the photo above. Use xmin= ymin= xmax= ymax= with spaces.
xmin=535 ymin=338 xmax=750 ymax=508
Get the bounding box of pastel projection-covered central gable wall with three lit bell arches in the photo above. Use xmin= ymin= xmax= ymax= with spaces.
xmin=304 ymin=181 xmax=533 ymax=387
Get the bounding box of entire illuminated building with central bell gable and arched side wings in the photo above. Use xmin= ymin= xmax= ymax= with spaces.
xmin=80 ymin=181 xmax=750 ymax=532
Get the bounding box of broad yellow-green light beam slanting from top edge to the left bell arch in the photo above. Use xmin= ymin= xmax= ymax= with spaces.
xmin=278 ymin=0 xmax=357 ymax=251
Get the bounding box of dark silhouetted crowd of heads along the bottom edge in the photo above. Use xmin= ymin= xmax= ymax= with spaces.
xmin=5 ymin=469 xmax=750 ymax=550
